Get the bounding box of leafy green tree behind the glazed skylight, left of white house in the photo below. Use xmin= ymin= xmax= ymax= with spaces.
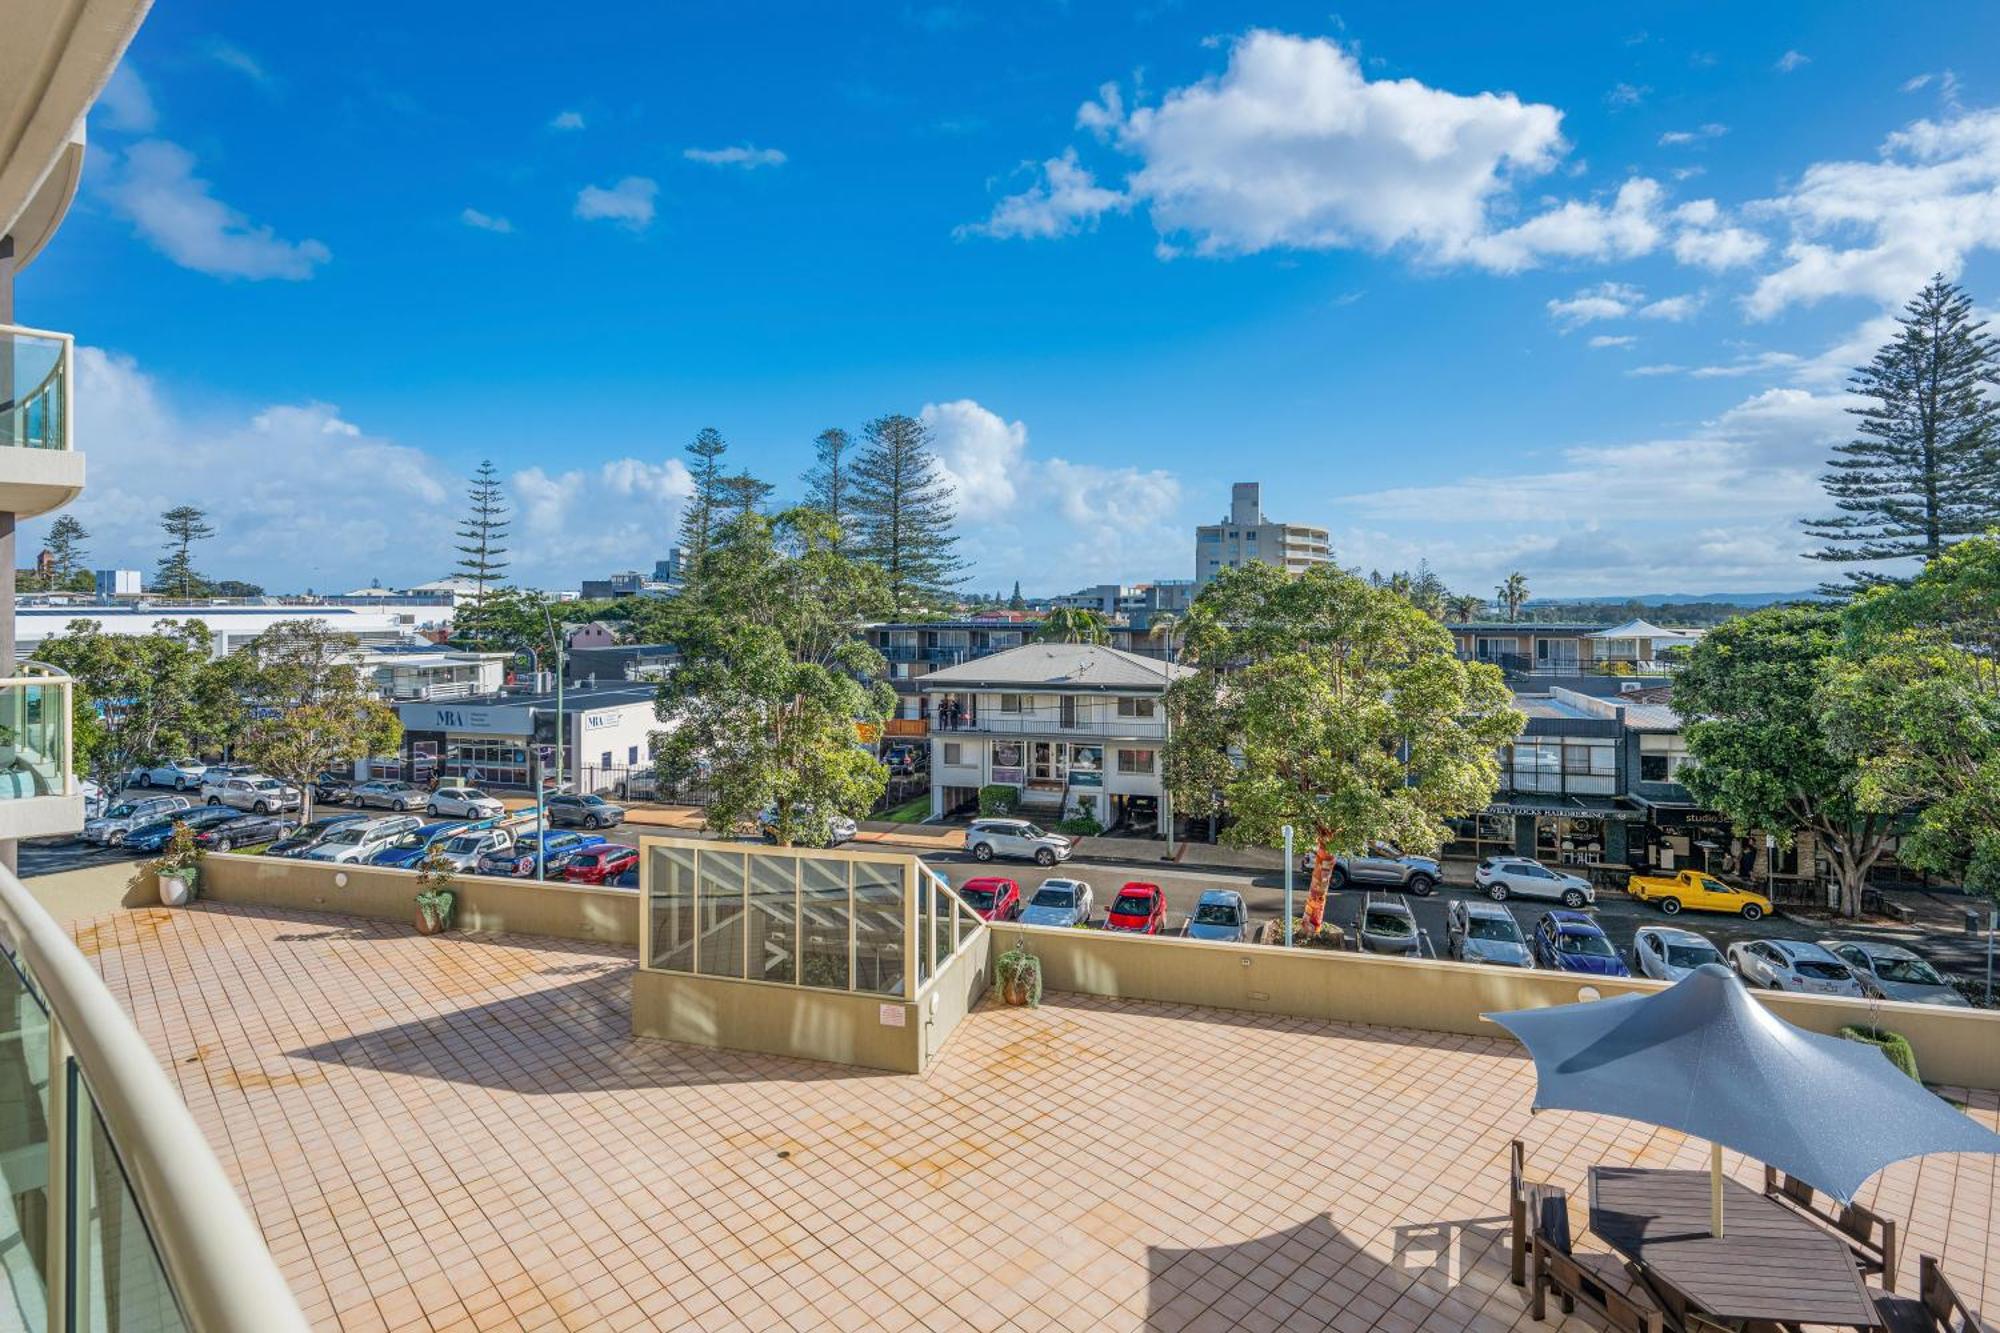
xmin=654 ymin=508 xmax=896 ymax=845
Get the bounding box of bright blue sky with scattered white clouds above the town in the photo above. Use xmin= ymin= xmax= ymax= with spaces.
xmin=18 ymin=0 xmax=2000 ymax=592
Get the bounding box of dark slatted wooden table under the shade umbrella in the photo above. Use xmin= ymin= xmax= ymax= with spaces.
xmin=1590 ymin=1167 xmax=1882 ymax=1329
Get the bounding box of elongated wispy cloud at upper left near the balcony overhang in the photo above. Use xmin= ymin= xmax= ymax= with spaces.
xmin=102 ymin=138 xmax=332 ymax=282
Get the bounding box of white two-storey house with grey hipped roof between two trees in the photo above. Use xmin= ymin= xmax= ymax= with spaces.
xmin=918 ymin=642 xmax=1192 ymax=831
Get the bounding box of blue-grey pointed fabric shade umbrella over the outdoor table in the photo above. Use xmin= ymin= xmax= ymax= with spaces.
xmin=1486 ymin=963 xmax=2000 ymax=1203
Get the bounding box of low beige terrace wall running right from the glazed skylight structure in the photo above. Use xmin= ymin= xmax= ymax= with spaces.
xmin=1008 ymin=923 xmax=2000 ymax=1089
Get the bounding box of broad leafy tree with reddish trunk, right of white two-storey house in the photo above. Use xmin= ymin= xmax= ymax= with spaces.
xmin=1166 ymin=564 xmax=1526 ymax=931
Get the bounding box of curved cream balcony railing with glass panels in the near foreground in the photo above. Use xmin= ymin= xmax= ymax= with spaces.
xmin=0 ymin=856 xmax=306 ymax=1333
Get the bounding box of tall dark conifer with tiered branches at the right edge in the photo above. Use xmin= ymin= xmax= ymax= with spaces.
xmin=1806 ymin=274 xmax=2000 ymax=594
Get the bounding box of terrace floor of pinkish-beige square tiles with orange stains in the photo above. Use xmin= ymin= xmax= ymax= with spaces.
xmin=76 ymin=905 xmax=2000 ymax=1333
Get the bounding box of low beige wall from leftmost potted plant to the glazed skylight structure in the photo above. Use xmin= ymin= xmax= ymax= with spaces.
xmin=202 ymin=853 xmax=638 ymax=949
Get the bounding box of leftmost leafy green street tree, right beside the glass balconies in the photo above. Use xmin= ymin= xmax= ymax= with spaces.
xmin=36 ymin=620 xmax=246 ymax=791
